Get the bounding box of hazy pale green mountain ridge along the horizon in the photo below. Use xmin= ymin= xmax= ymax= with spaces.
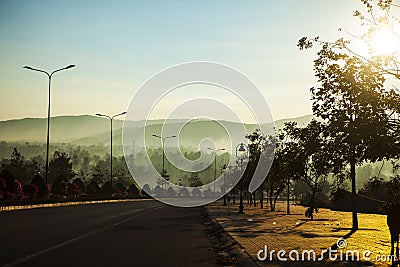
xmin=0 ymin=115 xmax=313 ymax=146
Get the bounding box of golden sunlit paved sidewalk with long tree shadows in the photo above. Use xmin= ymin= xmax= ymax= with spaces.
xmin=207 ymin=201 xmax=390 ymax=266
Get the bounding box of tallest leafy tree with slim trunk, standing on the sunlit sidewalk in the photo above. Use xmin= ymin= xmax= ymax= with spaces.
xmin=304 ymin=44 xmax=394 ymax=230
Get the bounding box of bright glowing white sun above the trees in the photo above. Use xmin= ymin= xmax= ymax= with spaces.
xmin=369 ymin=28 xmax=400 ymax=56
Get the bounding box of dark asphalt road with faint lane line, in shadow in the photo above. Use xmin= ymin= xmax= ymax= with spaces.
xmin=0 ymin=200 xmax=217 ymax=266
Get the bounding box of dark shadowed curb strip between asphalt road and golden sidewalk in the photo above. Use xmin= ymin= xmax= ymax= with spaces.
xmin=205 ymin=207 xmax=257 ymax=267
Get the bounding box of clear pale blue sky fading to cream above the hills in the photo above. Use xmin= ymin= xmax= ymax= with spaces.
xmin=0 ymin=0 xmax=363 ymax=120
